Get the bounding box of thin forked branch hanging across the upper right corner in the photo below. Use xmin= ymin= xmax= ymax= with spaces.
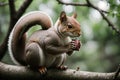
xmin=57 ymin=0 xmax=120 ymax=35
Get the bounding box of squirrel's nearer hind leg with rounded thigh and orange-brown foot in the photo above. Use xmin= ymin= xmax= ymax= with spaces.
xmin=26 ymin=42 xmax=47 ymax=74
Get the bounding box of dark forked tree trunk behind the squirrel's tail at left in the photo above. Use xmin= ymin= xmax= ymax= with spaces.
xmin=0 ymin=0 xmax=33 ymax=60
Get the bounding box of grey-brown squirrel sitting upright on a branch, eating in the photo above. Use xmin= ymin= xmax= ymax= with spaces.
xmin=8 ymin=11 xmax=81 ymax=73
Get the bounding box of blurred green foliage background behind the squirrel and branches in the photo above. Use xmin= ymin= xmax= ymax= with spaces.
xmin=0 ymin=0 xmax=120 ymax=72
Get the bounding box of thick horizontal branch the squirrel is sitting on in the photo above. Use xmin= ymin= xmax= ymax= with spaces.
xmin=0 ymin=62 xmax=120 ymax=80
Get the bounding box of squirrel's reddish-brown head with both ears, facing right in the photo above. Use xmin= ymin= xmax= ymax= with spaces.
xmin=58 ymin=11 xmax=81 ymax=37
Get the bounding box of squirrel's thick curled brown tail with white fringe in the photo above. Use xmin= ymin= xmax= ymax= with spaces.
xmin=8 ymin=11 xmax=53 ymax=65
